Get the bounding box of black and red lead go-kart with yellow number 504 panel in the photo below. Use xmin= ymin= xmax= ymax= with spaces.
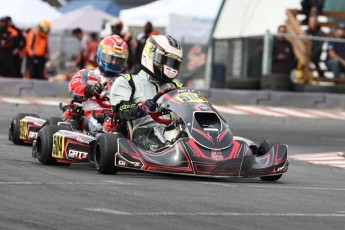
xmin=36 ymin=88 xmax=289 ymax=181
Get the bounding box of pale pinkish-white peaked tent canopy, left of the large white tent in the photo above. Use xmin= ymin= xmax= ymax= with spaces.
xmin=52 ymin=5 xmax=113 ymax=32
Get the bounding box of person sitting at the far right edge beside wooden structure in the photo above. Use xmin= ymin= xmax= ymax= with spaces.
xmin=327 ymin=23 xmax=345 ymax=78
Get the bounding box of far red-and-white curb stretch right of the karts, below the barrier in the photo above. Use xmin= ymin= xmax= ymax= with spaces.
xmin=213 ymin=105 xmax=345 ymax=120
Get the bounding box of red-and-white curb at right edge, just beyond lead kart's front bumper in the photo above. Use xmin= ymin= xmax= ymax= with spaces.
xmin=289 ymin=152 xmax=345 ymax=169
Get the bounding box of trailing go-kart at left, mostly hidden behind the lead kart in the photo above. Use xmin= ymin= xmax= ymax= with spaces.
xmin=8 ymin=100 xmax=84 ymax=145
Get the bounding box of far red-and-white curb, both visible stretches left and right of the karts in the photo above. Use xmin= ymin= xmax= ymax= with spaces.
xmin=0 ymin=97 xmax=345 ymax=120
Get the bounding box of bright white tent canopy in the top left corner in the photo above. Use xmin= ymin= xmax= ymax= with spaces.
xmin=0 ymin=0 xmax=62 ymax=27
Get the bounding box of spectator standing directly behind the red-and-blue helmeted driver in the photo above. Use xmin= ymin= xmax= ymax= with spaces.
xmin=110 ymin=18 xmax=133 ymax=72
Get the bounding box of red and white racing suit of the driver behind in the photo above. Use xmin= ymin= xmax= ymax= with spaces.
xmin=69 ymin=68 xmax=113 ymax=132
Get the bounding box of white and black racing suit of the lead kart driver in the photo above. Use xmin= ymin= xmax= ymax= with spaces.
xmin=109 ymin=70 xmax=175 ymax=151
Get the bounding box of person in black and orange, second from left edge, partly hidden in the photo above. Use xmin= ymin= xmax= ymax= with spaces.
xmin=6 ymin=17 xmax=26 ymax=78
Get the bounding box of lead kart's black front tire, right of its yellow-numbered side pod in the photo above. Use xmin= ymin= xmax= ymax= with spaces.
xmin=93 ymin=133 xmax=123 ymax=174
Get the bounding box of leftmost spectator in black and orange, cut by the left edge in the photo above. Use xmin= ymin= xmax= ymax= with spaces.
xmin=0 ymin=17 xmax=18 ymax=77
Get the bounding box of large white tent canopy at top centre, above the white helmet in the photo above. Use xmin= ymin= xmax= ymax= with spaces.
xmin=120 ymin=0 xmax=222 ymax=44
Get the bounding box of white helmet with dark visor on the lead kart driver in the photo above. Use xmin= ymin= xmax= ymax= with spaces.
xmin=141 ymin=35 xmax=182 ymax=82
